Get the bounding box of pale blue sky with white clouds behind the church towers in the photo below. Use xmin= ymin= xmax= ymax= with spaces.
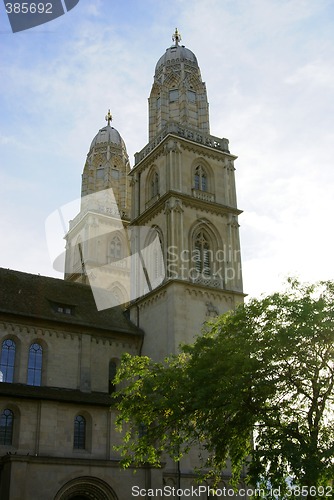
xmin=0 ymin=0 xmax=334 ymax=295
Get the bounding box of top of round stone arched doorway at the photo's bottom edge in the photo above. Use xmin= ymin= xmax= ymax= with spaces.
xmin=54 ymin=476 xmax=117 ymax=500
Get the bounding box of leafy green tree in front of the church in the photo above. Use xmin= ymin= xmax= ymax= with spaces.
xmin=116 ymin=279 xmax=334 ymax=498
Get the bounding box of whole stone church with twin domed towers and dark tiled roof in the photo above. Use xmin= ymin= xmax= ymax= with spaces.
xmin=0 ymin=30 xmax=244 ymax=500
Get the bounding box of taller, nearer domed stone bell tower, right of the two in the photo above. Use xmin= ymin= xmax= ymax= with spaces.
xmin=130 ymin=30 xmax=244 ymax=360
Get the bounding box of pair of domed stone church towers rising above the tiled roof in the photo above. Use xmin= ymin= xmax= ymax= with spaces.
xmin=65 ymin=29 xmax=244 ymax=360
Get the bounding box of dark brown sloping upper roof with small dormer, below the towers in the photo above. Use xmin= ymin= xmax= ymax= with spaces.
xmin=0 ymin=268 xmax=143 ymax=336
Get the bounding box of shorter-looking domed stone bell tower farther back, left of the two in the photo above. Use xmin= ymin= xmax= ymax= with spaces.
xmin=65 ymin=111 xmax=131 ymax=308
